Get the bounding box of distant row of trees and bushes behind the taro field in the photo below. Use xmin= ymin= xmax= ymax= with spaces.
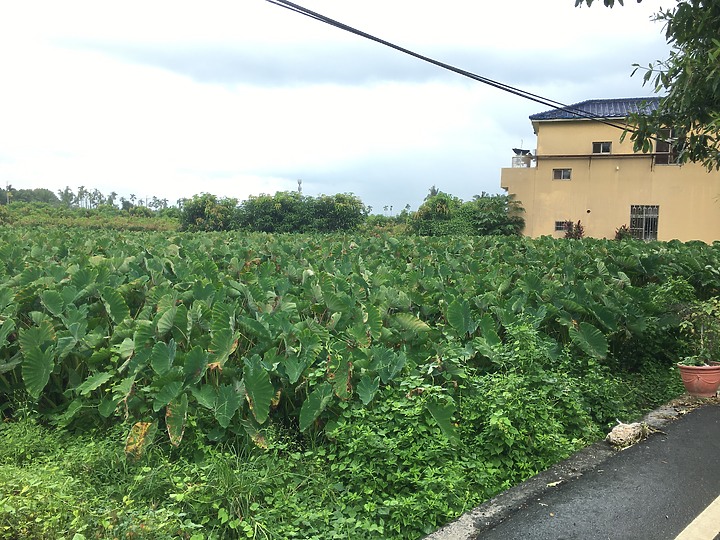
xmin=0 ymin=186 xmax=524 ymax=236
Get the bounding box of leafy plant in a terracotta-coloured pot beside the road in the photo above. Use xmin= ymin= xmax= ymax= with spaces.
xmin=678 ymin=296 xmax=720 ymax=397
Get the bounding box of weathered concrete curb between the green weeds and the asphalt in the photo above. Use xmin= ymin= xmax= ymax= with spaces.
xmin=425 ymin=396 xmax=720 ymax=540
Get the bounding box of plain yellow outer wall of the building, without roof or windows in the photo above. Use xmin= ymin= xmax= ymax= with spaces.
xmin=501 ymin=120 xmax=720 ymax=243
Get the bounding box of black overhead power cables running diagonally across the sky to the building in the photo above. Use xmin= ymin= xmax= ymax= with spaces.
xmin=267 ymin=0 xmax=627 ymax=131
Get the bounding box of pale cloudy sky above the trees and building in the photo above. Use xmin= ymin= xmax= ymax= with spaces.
xmin=0 ymin=0 xmax=669 ymax=214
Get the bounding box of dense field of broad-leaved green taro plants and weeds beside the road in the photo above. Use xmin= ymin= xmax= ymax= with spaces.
xmin=0 ymin=229 xmax=720 ymax=539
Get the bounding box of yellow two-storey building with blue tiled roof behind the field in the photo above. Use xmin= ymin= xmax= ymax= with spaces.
xmin=501 ymin=98 xmax=720 ymax=243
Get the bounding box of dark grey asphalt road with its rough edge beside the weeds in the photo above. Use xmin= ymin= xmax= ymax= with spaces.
xmin=431 ymin=404 xmax=720 ymax=540
